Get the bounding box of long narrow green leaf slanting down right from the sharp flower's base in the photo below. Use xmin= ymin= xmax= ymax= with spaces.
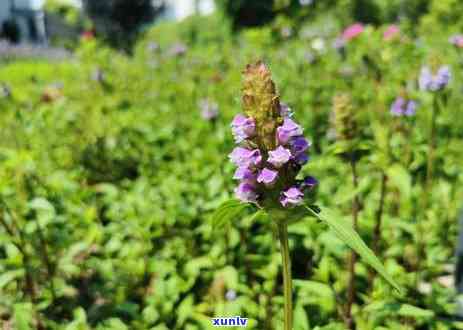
xmin=306 ymin=207 xmax=402 ymax=293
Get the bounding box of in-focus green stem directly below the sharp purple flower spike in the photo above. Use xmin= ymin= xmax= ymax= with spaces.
xmin=278 ymin=223 xmax=293 ymax=330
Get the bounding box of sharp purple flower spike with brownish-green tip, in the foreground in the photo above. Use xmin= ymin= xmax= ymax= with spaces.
xmin=228 ymin=61 xmax=316 ymax=209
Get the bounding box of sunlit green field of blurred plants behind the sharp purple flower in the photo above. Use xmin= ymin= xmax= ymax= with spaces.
xmin=0 ymin=5 xmax=463 ymax=330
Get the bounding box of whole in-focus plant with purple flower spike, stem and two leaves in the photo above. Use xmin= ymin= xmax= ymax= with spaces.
xmin=212 ymin=61 xmax=400 ymax=330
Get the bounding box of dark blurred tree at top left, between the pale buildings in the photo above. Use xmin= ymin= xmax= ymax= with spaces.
xmin=84 ymin=0 xmax=165 ymax=50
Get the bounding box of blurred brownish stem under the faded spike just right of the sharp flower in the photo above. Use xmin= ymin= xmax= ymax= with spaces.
xmin=346 ymin=156 xmax=360 ymax=329
